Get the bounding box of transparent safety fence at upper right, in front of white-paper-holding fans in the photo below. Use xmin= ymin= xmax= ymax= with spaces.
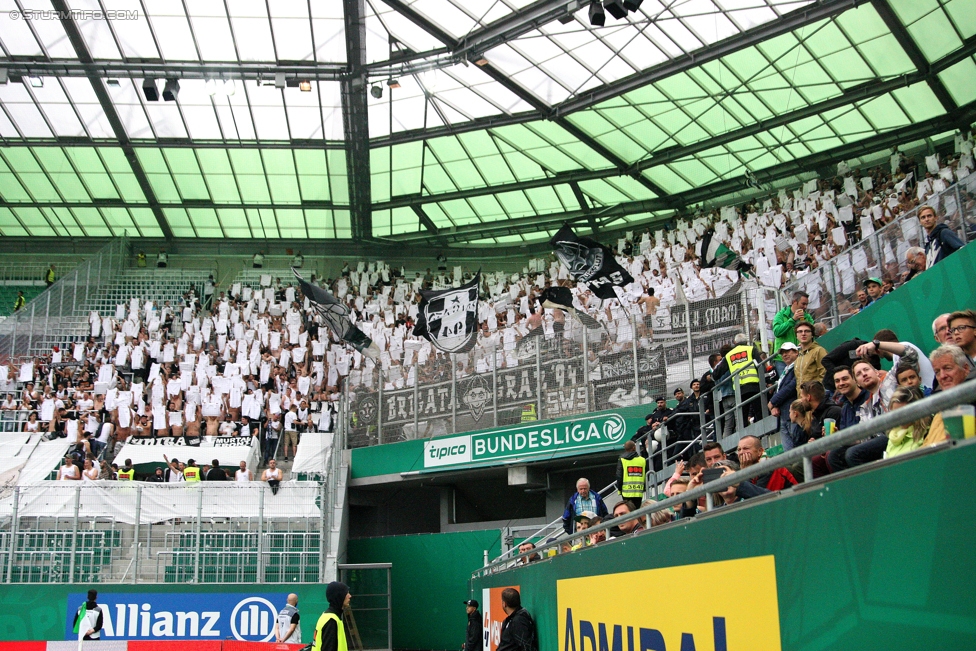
xmin=780 ymin=174 xmax=976 ymax=327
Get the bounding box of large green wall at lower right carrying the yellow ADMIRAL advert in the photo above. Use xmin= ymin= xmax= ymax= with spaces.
xmin=472 ymin=441 xmax=976 ymax=651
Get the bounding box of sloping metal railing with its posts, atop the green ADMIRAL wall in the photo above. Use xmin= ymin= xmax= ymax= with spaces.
xmin=472 ymin=381 xmax=976 ymax=578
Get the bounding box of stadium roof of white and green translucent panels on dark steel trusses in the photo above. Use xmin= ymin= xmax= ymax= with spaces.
xmin=0 ymin=0 xmax=976 ymax=246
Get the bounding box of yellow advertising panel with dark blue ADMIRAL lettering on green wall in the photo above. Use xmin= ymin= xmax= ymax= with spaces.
xmin=556 ymin=556 xmax=780 ymax=651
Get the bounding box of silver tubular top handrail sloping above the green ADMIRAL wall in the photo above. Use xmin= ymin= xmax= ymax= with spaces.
xmin=472 ymin=381 xmax=976 ymax=578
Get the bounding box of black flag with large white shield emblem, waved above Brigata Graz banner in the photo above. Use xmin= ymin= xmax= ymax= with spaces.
xmin=413 ymin=271 xmax=481 ymax=353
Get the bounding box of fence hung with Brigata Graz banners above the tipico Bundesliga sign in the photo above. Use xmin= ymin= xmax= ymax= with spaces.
xmin=344 ymin=283 xmax=776 ymax=447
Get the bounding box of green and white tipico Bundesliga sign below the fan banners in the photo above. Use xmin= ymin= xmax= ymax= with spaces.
xmin=424 ymin=414 xmax=627 ymax=468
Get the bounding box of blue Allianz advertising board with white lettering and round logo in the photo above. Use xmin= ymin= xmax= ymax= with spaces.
xmin=65 ymin=591 xmax=288 ymax=642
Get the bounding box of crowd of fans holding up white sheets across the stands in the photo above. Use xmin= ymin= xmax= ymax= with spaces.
xmin=0 ymin=135 xmax=973 ymax=494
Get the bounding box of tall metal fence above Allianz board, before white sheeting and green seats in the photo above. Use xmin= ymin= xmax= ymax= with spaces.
xmin=0 ymin=484 xmax=339 ymax=583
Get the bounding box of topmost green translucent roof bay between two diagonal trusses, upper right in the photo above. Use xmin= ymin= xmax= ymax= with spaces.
xmin=569 ymin=4 xmax=914 ymax=163
